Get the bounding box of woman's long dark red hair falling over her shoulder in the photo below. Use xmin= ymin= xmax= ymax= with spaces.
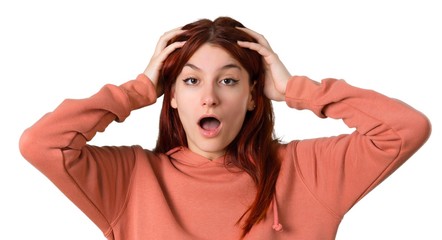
xmin=154 ymin=17 xmax=281 ymax=237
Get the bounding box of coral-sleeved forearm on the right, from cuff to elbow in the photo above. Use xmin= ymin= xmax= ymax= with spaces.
xmin=286 ymin=77 xmax=430 ymax=155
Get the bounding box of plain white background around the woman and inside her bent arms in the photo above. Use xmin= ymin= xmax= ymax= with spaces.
xmin=0 ymin=0 xmax=442 ymax=240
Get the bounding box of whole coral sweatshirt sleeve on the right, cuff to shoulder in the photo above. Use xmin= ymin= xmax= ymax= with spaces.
xmin=286 ymin=76 xmax=431 ymax=217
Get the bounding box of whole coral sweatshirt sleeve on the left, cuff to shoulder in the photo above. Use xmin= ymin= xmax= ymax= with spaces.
xmin=19 ymin=74 xmax=156 ymax=233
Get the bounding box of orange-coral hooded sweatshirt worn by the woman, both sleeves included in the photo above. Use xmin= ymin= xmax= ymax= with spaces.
xmin=20 ymin=74 xmax=431 ymax=240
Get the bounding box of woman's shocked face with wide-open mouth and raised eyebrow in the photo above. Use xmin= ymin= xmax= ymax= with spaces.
xmin=171 ymin=44 xmax=254 ymax=159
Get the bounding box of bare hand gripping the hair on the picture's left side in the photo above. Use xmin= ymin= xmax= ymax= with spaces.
xmin=144 ymin=27 xmax=186 ymax=97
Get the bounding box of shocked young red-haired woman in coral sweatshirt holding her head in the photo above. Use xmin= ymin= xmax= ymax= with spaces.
xmin=20 ymin=17 xmax=431 ymax=240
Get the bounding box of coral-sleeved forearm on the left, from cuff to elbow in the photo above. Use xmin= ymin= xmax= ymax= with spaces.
xmin=20 ymin=74 xmax=156 ymax=171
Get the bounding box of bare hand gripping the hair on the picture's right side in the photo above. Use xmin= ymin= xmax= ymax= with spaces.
xmin=238 ymin=27 xmax=291 ymax=101
